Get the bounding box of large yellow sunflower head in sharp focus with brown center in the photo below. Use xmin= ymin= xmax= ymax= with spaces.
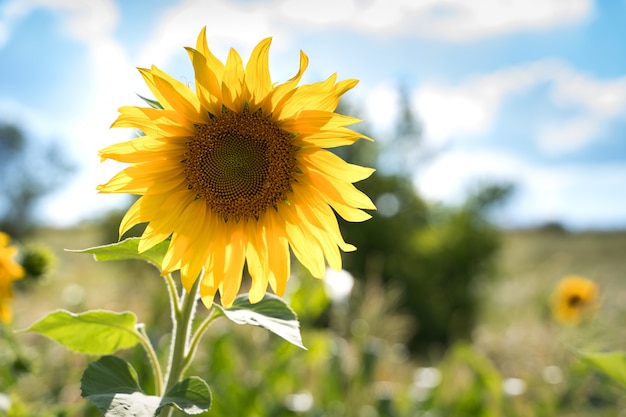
xmin=98 ymin=29 xmax=375 ymax=306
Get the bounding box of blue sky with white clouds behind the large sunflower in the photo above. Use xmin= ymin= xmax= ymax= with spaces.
xmin=0 ymin=0 xmax=626 ymax=229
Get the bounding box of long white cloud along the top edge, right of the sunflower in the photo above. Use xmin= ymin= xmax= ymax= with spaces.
xmin=277 ymin=0 xmax=592 ymax=42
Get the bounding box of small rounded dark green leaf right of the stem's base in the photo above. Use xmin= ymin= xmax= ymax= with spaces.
xmin=161 ymin=376 xmax=211 ymax=414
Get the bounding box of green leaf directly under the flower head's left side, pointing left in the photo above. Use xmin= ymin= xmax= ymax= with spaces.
xmin=70 ymin=237 xmax=170 ymax=268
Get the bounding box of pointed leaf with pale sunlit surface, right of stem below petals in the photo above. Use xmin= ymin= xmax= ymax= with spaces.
xmin=215 ymin=294 xmax=306 ymax=349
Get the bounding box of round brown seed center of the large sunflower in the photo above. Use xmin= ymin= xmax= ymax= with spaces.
xmin=184 ymin=108 xmax=296 ymax=221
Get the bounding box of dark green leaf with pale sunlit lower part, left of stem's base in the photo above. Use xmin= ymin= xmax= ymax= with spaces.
xmin=80 ymin=356 xmax=161 ymax=417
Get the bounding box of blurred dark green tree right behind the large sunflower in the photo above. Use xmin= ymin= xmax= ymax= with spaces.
xmin=337 ymin=90 xmax=512 ymax=353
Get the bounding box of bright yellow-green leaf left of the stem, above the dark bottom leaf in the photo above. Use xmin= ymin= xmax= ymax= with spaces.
xmin=26 ymin=310 xmax=140 ymax=355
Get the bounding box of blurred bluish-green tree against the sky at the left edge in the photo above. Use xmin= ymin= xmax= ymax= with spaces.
xmin=0 ymin=124 xmax=73 ymax=238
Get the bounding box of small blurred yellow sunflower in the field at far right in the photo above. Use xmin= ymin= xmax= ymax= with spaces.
xmin=552 ymin=275 xmax=598 ymax=324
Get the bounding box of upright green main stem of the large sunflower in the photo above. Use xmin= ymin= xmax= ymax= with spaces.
xmin=165 ymin=276 xmax=202 ymax=392
